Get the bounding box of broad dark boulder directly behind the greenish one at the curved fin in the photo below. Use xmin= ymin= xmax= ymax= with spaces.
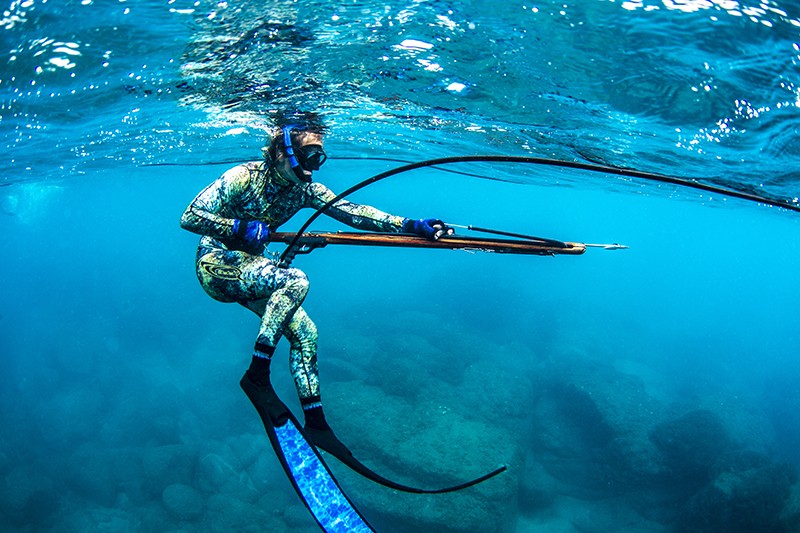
xmin=354 ymin=311 xmax=536 ymax=432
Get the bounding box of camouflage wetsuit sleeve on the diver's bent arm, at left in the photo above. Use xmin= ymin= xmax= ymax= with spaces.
xmin=181 ymin=165 xmax=250 ymax=239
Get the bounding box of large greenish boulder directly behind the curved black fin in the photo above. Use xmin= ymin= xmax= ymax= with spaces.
xmin=326 ymin=382 xmax=521 ymax=532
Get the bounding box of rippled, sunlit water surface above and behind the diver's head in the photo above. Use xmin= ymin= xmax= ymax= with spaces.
xmin=0 ymin=0 xmax=800 ymax=205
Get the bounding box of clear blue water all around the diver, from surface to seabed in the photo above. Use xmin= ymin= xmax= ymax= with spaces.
xmin=0 ymin=0 xmax=800 ymax=532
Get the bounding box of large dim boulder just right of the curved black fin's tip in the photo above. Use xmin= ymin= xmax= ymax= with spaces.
xmin=530 ymin=357 xmax=664 ymax=499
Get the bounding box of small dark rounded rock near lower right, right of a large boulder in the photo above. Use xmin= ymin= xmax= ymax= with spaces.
xmin=650 ymin=409 xmax=732 ymax=484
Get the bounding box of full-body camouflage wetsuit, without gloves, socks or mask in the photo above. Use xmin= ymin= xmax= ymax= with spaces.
xmin=181 ymin=161 xmax=404 ymax=405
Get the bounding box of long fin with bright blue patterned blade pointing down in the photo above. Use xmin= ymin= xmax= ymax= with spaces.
xmin=239 ymin=374 xmax=375 ymax=533
